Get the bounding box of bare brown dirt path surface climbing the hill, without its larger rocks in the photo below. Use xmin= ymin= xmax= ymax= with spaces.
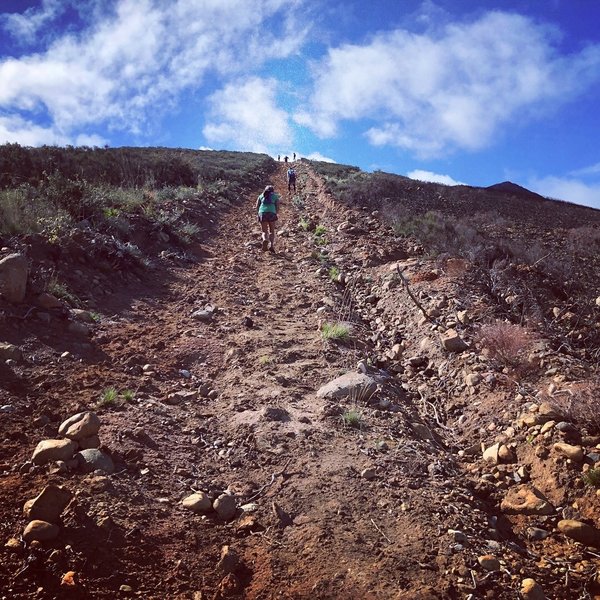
xmin=5 ymin=163 xmax=600 ymax=600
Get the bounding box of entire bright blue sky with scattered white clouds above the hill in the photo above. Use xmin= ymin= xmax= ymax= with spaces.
xmin=0 ymin=0 xmax=600 ymax=208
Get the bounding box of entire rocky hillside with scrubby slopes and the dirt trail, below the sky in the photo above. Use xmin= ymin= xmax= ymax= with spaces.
xmin=0 ymin=147 xmax=600 ymax=600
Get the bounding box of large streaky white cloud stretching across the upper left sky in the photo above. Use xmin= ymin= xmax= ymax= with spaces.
xmin=0 ymin=0 xmax=306 ymax=143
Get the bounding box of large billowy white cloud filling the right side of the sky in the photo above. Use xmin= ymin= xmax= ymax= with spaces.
xmin=295 ymin=12 xmax=600 ymax=156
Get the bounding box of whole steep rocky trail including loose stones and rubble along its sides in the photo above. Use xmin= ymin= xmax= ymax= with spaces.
xmin=0 ymin=163 xmax=600 ymax=600
